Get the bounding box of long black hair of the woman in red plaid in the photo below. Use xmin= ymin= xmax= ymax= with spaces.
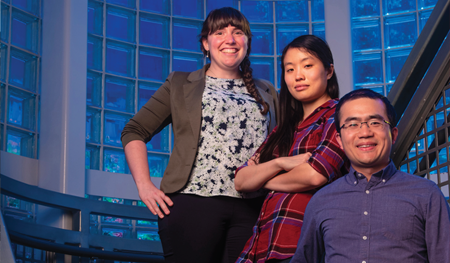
xmin=259 ymin=35 xmax=339 ymax=163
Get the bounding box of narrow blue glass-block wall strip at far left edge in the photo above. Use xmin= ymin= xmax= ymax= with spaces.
xmin=0 ymin=0 xmax=42 ymax=158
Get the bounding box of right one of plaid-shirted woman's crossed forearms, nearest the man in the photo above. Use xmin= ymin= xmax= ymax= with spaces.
xmin=264 ymin=163 xmax=328 ymax=193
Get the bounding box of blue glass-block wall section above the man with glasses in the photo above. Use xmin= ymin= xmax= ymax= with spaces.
xmin=350 ymin=0 xmax=437 ymax=95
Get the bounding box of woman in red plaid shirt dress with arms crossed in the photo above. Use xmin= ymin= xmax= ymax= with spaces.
xmin=234 ymin=35 xmax=349 ymax=263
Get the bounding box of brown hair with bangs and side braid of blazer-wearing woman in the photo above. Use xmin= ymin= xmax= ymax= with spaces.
xmin=199 ymin=7 xmax=269 ymax=115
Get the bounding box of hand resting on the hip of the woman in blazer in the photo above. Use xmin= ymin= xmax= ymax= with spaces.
xmin=139 ymin=185 xmax=173 ymax=218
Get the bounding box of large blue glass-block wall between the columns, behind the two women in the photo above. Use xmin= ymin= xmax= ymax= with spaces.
xmin=86 ymin=0 xmax=325 ymax=177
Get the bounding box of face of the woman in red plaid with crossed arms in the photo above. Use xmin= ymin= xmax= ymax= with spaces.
xmin=283 ymin=48 xmax=334 ymax=109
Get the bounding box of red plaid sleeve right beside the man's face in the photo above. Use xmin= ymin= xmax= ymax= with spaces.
xmin=308 ymin=108 xmax=347 ymax=182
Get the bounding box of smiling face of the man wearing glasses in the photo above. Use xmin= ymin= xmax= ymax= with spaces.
xmin=337 ymin=98 xmax=398 ymax=179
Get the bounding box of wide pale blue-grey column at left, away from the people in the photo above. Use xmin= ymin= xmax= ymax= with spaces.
xmin=38 ymin=0 xmax=88 ymax=197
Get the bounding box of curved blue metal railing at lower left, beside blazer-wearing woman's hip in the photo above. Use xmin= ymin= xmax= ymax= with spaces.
xmin=0 ymin=175 xmax=164 ymax=262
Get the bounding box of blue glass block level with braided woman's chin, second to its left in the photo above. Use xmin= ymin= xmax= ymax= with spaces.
xmin=139 ymin=48 xmax=170 ymax=81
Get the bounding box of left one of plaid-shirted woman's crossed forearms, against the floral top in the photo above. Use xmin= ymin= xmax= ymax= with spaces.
xmin=234 ymin=159 xmax=283 ymax=192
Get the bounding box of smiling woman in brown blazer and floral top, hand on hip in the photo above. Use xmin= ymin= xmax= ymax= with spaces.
xmin=122 ymin=7 xmax=277 ymax=263
